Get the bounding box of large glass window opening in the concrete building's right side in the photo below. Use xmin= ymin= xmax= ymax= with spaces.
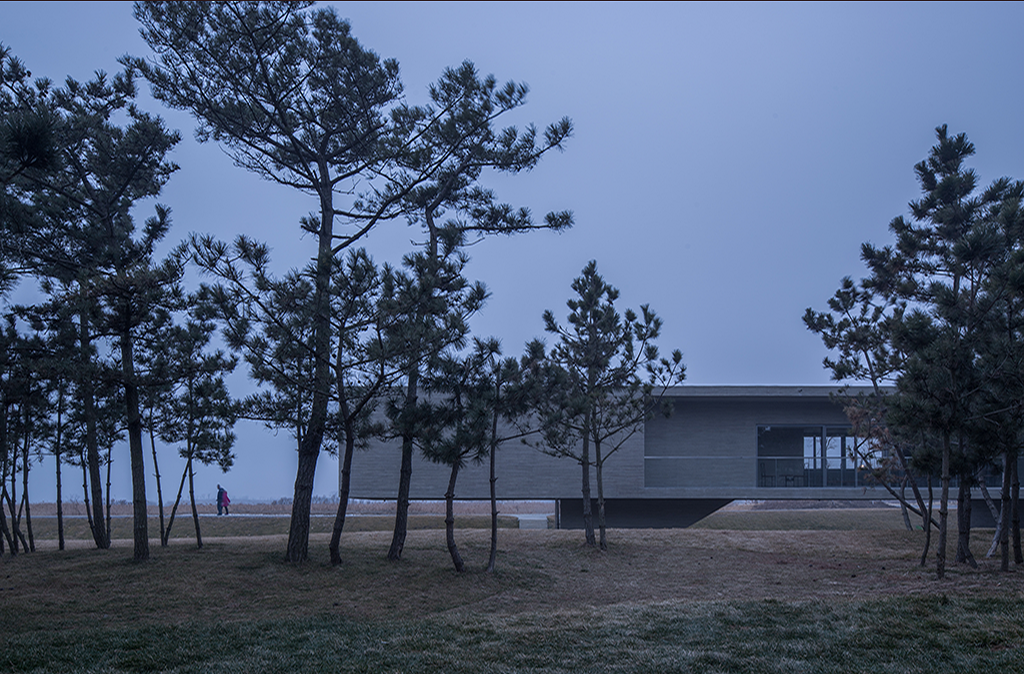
xmin=757 ymin=426 xmax=868 ymax=488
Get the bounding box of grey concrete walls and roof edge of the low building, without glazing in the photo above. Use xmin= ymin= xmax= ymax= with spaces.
xmin=351 ymin=386 xmax=883 ymax=500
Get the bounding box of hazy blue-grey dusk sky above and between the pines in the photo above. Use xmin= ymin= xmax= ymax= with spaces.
xmin=6 ymin=2 xmax=1024 ymax=500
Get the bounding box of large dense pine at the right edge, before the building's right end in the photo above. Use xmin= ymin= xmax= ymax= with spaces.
xmin=805 ymin=126 xmax=1020 ymax=578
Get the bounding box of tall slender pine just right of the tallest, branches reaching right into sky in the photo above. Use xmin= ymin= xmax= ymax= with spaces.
xmin=386 ymin=61 xmax=572 ymax=560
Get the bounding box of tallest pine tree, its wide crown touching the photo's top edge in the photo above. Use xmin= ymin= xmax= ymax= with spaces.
xmin=129 ymin=2 xmax=401 ymax=561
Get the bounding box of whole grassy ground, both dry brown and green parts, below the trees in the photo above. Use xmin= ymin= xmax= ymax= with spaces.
xmin=0 ymin=510 xmax=1024 ymax=673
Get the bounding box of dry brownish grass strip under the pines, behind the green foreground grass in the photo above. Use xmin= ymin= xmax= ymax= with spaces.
xmin=0 ymin=512 xmax=1024 ymax=634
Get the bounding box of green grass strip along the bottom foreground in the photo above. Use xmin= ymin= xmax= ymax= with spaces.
xmin=0 ymin=597 xmax=1024 ymax=674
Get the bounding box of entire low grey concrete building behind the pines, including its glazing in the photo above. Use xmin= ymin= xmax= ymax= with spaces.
xmin=351 ymin=386 xmax=889 ymax=528
